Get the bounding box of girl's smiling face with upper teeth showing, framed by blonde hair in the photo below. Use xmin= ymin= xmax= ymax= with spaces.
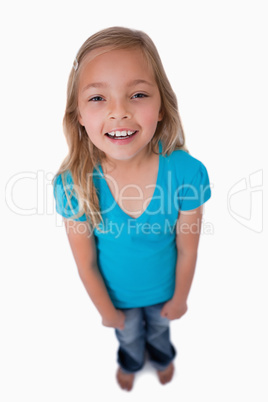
xmin=78 ymin=48 xmax=162 ymax=160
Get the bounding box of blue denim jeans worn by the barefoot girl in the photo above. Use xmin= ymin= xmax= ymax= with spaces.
xmin=115 ymin=303 xmax=176 ymax=373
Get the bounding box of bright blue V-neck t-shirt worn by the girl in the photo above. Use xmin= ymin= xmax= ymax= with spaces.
xmin=54 ymin=146 xmax=211 ymax=308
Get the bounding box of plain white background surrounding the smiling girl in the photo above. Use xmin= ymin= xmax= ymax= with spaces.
xmin=0 ymin=0 xmax=268 ymax=402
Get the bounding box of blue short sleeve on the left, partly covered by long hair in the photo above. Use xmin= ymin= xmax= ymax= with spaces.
xmin=53 ymin=172 xmax=87 ymax=221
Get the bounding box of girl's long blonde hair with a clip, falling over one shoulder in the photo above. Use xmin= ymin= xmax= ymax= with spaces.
xmin=55 ymin=27 xmax=187 ymax=227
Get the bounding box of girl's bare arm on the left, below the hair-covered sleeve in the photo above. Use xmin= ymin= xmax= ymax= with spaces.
xmin=64 ymin=219 xmax=125 ymax=329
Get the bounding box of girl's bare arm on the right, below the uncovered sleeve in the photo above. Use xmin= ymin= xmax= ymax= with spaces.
xmin=161 ymin=206 xmax=203 ymax=320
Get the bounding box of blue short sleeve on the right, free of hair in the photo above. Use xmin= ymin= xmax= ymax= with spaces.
xmin=179 ymin=162 xmax=211 ymax=211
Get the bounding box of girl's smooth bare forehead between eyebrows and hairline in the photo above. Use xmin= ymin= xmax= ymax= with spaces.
xmin=79 ymin=47 xmax=155 ymax=88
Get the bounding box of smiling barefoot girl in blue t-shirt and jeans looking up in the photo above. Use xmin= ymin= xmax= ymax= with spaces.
xmin=54 ymin=27 xmax=210 ymax=390
